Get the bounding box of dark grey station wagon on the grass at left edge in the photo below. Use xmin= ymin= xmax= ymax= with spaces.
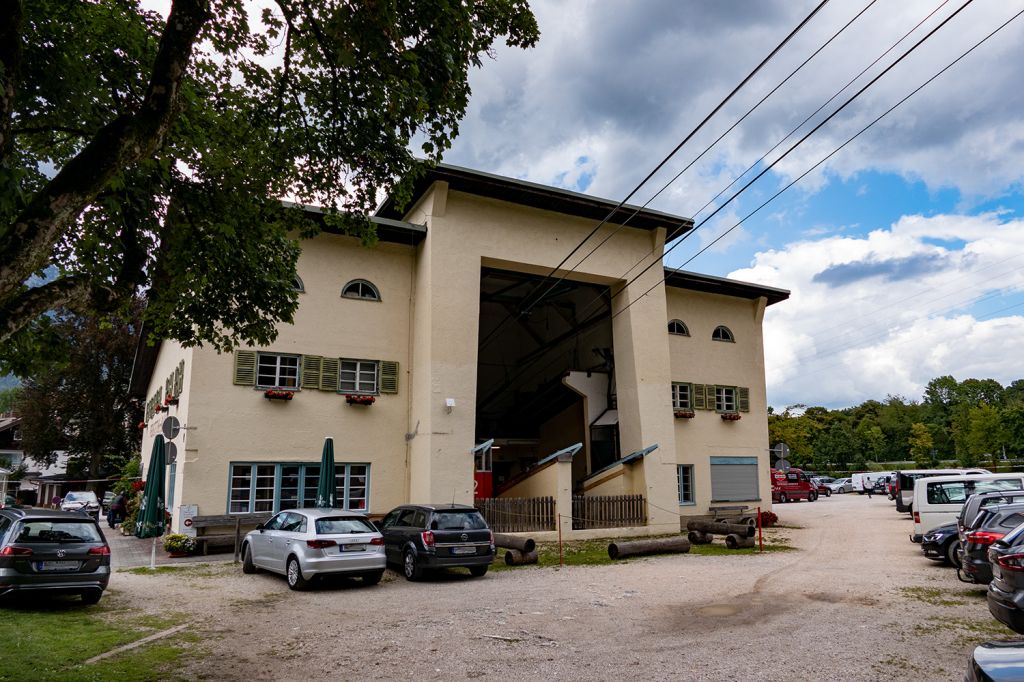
xmin=0 ymin=508 xmax=111 ymax=604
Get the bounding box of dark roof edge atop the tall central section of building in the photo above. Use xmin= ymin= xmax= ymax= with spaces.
xmin=376 ymin=164 xmax=693 ymax=237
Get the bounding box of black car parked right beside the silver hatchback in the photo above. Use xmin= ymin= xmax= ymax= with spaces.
xmin=379 ymin=505 xmax=495 ymax=581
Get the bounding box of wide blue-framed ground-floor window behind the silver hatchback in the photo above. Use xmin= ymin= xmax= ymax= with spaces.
xmin=227 ymin=463 xmax=370 ymax=514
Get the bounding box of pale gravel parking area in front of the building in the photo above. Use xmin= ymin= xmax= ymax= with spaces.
xmin=106 ymin=495 xmax=1015 ymax=681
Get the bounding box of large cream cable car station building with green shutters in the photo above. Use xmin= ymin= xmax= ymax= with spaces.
xmin=132 ymin=166 xmax=788 ymax=532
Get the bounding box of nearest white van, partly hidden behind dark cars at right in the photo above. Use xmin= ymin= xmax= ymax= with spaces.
xmin=910 ymin=473 xmax=1024 ymax=543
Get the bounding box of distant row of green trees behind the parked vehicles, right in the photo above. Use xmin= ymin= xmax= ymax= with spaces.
xmin=768 ymin=375 xmax=1024 ymax=472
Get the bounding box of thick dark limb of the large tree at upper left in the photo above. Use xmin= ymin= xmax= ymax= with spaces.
xmin=0 ymin=0 xmax=210 ymax=333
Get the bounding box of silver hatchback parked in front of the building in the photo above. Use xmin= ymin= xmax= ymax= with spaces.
xmin=242 ymin=509 xmax=386 ymax=590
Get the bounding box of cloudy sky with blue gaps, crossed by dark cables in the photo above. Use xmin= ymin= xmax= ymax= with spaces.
xmin=445 ymin=0 xmax=1024 ymax=409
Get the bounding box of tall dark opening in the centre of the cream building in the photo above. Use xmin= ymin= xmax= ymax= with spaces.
xmin=476 ymin=267 xmax=620 ymax=497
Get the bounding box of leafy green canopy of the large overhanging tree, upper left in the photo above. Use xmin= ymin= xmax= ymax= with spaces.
xmin=0 ymin=0 xmax=539 ymax=357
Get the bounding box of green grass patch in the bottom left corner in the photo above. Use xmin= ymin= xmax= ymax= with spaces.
xmin=0 ymin=596 xmax=193 ymax=682
